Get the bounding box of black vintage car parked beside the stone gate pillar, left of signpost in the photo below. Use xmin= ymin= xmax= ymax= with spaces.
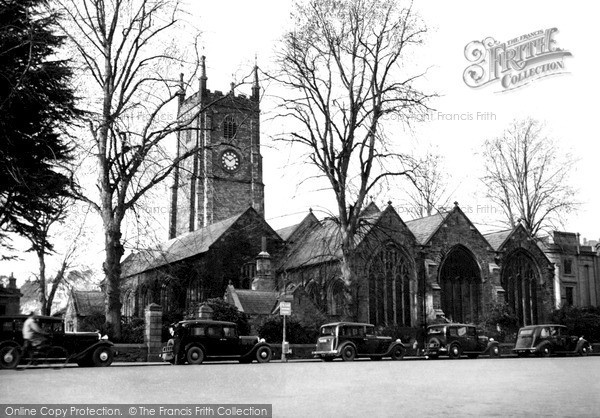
xmin=161 ymin=319 xmax=272 ymax=364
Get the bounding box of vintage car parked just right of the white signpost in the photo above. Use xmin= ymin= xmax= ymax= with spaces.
xmin=312 ymin=322 xmax=405 ymax=361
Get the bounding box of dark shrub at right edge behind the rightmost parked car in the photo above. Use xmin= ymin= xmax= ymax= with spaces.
xmin=550 ymin=306 xmax=600 ymax=342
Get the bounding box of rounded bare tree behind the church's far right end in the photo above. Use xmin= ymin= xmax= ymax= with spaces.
xmin=482 ymin=118 xmax=577 ymax=236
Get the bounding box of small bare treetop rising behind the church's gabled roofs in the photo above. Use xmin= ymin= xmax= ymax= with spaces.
xmin=405 ymin=151 xmax=450 ymax=218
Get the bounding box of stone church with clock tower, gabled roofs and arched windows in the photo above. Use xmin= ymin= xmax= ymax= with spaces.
xmin=122 ymin=57 xmax=600 ymax=327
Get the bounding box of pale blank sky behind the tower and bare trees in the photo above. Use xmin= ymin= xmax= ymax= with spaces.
xmin=0 ymin=0 xmax=600 ymax=286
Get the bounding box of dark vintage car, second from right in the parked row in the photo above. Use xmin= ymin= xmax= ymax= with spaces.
xmin=424 ymin=324 xmax=500 ymax=359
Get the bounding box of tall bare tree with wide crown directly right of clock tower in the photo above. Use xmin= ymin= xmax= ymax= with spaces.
xmin=275 ymin=0 xmax=429 ymax=316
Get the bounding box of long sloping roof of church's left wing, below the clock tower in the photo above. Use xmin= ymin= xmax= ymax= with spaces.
xmin=121 ymin=208 xmax=270 ymax=278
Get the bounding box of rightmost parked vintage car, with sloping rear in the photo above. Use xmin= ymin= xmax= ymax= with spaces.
xmin=513 ymin=324 xmax=592 ymax=357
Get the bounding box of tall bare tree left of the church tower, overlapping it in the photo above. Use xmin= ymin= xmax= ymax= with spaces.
xmin=51 ymin=0 xmax=243 ymax=338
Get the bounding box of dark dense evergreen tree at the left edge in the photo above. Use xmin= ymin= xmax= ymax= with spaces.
xmin=0 ymin=0 xmax=80 ymax=251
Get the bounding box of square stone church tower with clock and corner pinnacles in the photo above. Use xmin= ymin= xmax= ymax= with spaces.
xmin=169 ymin=57 xmax=264 ymax=238
